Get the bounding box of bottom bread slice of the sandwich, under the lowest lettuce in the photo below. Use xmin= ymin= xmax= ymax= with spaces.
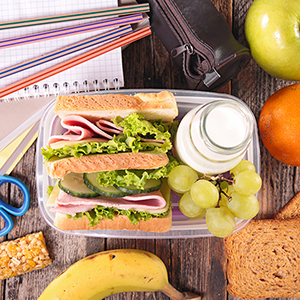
xmin=54 ymin=209 xmax=172 ymax=232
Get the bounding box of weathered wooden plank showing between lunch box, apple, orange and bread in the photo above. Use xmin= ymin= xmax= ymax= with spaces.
xmin=232 ymin=1 xmax=296 ymax=219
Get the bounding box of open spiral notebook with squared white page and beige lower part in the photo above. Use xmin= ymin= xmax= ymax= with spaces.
xmin=0 ymin=0 xmax=124 ymax=150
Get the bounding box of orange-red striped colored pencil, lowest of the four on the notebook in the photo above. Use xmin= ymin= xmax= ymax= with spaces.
xmin=0 ymin=26 xmax=151 ymax=98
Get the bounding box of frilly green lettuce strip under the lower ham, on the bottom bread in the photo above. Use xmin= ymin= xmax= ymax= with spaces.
xmin=67 ymin=205 xmax=171 ymax=227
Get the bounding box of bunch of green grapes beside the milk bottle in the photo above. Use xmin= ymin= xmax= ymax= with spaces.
xmin=168 ymin=160 xmax=262 ymax=237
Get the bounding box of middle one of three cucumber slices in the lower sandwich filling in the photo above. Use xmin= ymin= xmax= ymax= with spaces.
xmin=83 ymin=173 xmax=130 ymax=198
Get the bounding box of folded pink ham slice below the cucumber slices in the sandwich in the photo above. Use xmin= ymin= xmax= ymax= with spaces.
xmin=51 ymin=190 xmax=166 ymax=215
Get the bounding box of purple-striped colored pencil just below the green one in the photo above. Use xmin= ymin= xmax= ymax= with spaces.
xmin=0 ymin=14 xmax=143 ymax=49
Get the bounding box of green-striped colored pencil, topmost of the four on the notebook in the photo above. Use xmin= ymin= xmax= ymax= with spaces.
xmin=0 ymin=3 xmax=150 ymax=30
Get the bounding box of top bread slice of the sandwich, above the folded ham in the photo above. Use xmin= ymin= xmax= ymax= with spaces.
xmin=54 ymin=91 xmax=178 ymax=122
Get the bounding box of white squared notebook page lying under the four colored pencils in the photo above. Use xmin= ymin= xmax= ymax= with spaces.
xmin=0 ymin=0 xmax=124 ymax=97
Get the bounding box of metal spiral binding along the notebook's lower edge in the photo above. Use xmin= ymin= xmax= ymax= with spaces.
xmin=0 ymin=78 xmax=121 ymax=102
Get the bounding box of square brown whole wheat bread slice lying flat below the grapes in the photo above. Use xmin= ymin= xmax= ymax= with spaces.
xmin=224 ymin=218 xmax=300 ymax=299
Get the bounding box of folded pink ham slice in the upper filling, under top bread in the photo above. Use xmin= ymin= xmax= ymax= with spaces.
xmin=48 ymin=116 xmax=113 ymax=145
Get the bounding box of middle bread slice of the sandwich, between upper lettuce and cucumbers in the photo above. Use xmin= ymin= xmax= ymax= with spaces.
xmin=46 ymin=152 xmax=169 ymax=178
